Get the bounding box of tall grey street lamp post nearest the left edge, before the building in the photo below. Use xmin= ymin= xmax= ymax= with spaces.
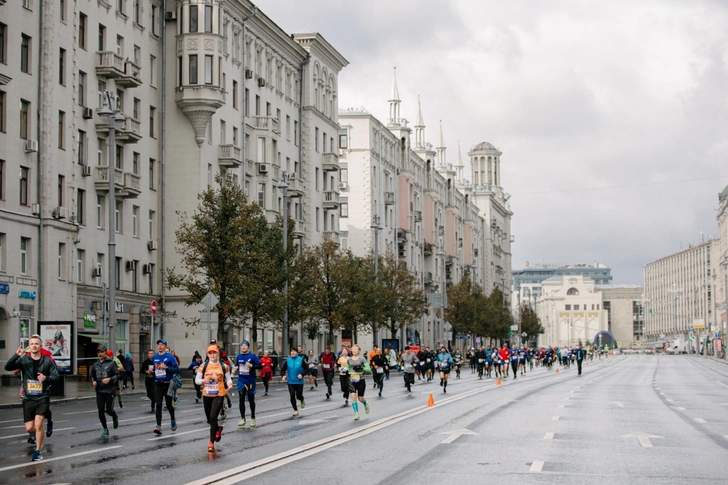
xmin=99 ymin=91 xmax=125 ymax=352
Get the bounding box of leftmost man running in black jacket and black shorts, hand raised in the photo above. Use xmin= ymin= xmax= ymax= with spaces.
xmin=5 ymin=334 xmax=58 ymax=461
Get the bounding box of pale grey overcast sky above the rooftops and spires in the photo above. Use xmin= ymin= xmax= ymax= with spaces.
xmin=256 ymin=0 xmax=728 ymax=284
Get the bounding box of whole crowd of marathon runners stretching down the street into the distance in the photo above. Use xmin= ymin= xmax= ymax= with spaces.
xmin=5 ymin=335 xmax=608 ymax=461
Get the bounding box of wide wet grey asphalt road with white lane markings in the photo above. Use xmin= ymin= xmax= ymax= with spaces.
xmin=0 ymin=355 xmax=728 ymax=485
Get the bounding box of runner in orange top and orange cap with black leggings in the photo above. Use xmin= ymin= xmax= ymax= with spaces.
xmin=196 ymin=345 xmax=233 ymax=452
